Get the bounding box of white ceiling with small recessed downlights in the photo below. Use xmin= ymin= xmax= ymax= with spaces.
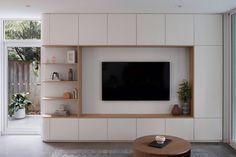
xmin=0 ymin=0 xmax=236 ymax=18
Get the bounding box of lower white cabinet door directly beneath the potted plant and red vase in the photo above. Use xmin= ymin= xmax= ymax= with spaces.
xmin=166 ymin=119 xmax=193 ymax=140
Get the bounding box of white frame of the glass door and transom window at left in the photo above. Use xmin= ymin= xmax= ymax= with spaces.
xmin=0 ymin=18 xmax=42 ymax=135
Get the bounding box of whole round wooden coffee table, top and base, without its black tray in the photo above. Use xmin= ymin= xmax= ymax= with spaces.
xmin=133 ymin=135 xmax=192 ymax=157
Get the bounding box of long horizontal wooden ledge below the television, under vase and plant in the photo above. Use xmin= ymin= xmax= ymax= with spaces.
xmin=79 ymin=114 xmax=194 ymax=118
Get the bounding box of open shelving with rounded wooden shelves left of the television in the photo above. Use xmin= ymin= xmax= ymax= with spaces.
xmin=41 ymin=45 xmax=82 ymax=118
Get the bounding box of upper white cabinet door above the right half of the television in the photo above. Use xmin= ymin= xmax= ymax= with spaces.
xmin=137 ymin=14 xmax=165 ymax=45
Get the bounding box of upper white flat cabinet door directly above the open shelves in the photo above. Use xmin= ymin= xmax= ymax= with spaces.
xmin=50 ymin=14 xmax=79 ymax=45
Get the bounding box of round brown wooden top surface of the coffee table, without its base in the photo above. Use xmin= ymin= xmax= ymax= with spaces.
xmin=133 ymin=135 xmax=192 ymax=155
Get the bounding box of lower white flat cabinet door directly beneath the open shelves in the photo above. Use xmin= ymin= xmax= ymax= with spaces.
xmin=50 ymin=118 xmax=79 ymax=141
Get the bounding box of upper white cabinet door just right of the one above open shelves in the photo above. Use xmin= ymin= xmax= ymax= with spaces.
xmin=79 ymin=14 xmax=107 ymax=45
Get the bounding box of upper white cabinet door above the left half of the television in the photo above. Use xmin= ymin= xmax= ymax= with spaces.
xmin=108 ymin=14 xmax=136 ymax=45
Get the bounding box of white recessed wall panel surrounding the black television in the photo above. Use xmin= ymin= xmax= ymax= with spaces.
xmin=82 ymin=47 xmax=189 ymax=114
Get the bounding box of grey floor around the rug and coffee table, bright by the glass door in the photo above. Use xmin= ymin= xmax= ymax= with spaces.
xmin=0 ymin=135 xmax=236 ymax=157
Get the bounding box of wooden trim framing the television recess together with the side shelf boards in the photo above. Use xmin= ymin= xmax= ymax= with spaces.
xmin=42 ymin=45 xmax=194 ymax=118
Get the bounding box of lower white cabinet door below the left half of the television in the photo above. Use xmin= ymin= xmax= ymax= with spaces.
xmin=108 ymin=118 xmax=136 ymax=140
